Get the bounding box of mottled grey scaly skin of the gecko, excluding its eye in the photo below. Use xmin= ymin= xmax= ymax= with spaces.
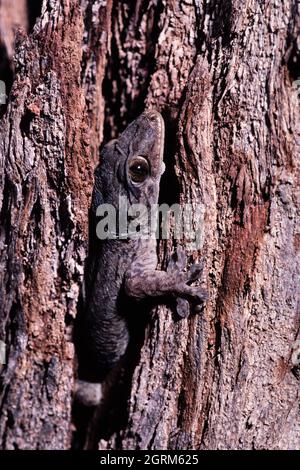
xmin=86 ymin=110 xmax=206 ymax=382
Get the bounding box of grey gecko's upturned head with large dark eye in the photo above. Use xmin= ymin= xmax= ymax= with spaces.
xmin=101 ymin=110 xmax=165 ymax=205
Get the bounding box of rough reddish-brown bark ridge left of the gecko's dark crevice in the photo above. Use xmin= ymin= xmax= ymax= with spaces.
xmin=0 ymin=0 xmax=110 ymax=449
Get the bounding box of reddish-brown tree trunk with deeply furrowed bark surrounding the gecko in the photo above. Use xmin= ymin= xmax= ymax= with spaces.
xmin=0 ymin=0 xmax=300 ymax=449
